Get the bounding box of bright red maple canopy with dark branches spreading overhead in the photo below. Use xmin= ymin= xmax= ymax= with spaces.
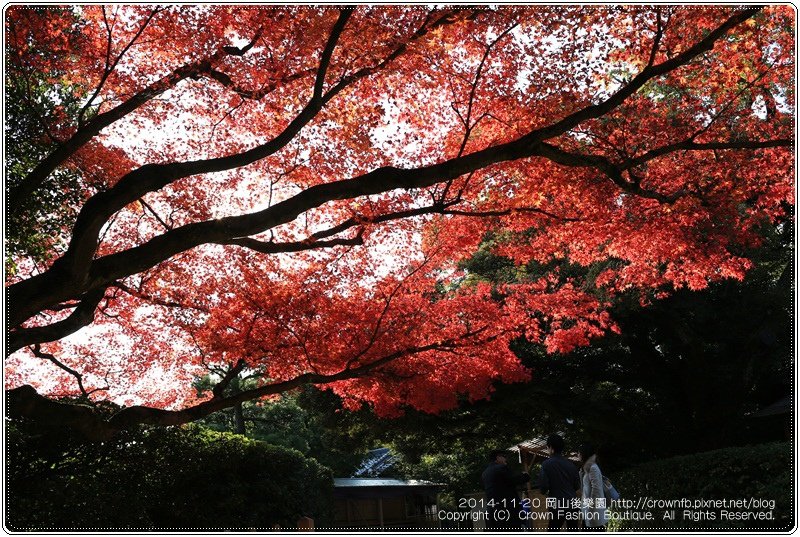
xmin=5 ymin=5 xmax=795 ymax=437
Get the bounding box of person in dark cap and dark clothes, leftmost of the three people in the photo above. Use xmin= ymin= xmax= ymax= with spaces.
xmin=481 ymin=450 xmax=531 ymax=530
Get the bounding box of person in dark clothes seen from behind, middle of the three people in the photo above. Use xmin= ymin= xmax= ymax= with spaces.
xmin=539 ymin=434 xmax=581 ymax=531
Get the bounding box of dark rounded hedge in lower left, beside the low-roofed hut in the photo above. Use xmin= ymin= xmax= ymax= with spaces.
xmin=5 ymin=425 xmax=333 ymax=531
